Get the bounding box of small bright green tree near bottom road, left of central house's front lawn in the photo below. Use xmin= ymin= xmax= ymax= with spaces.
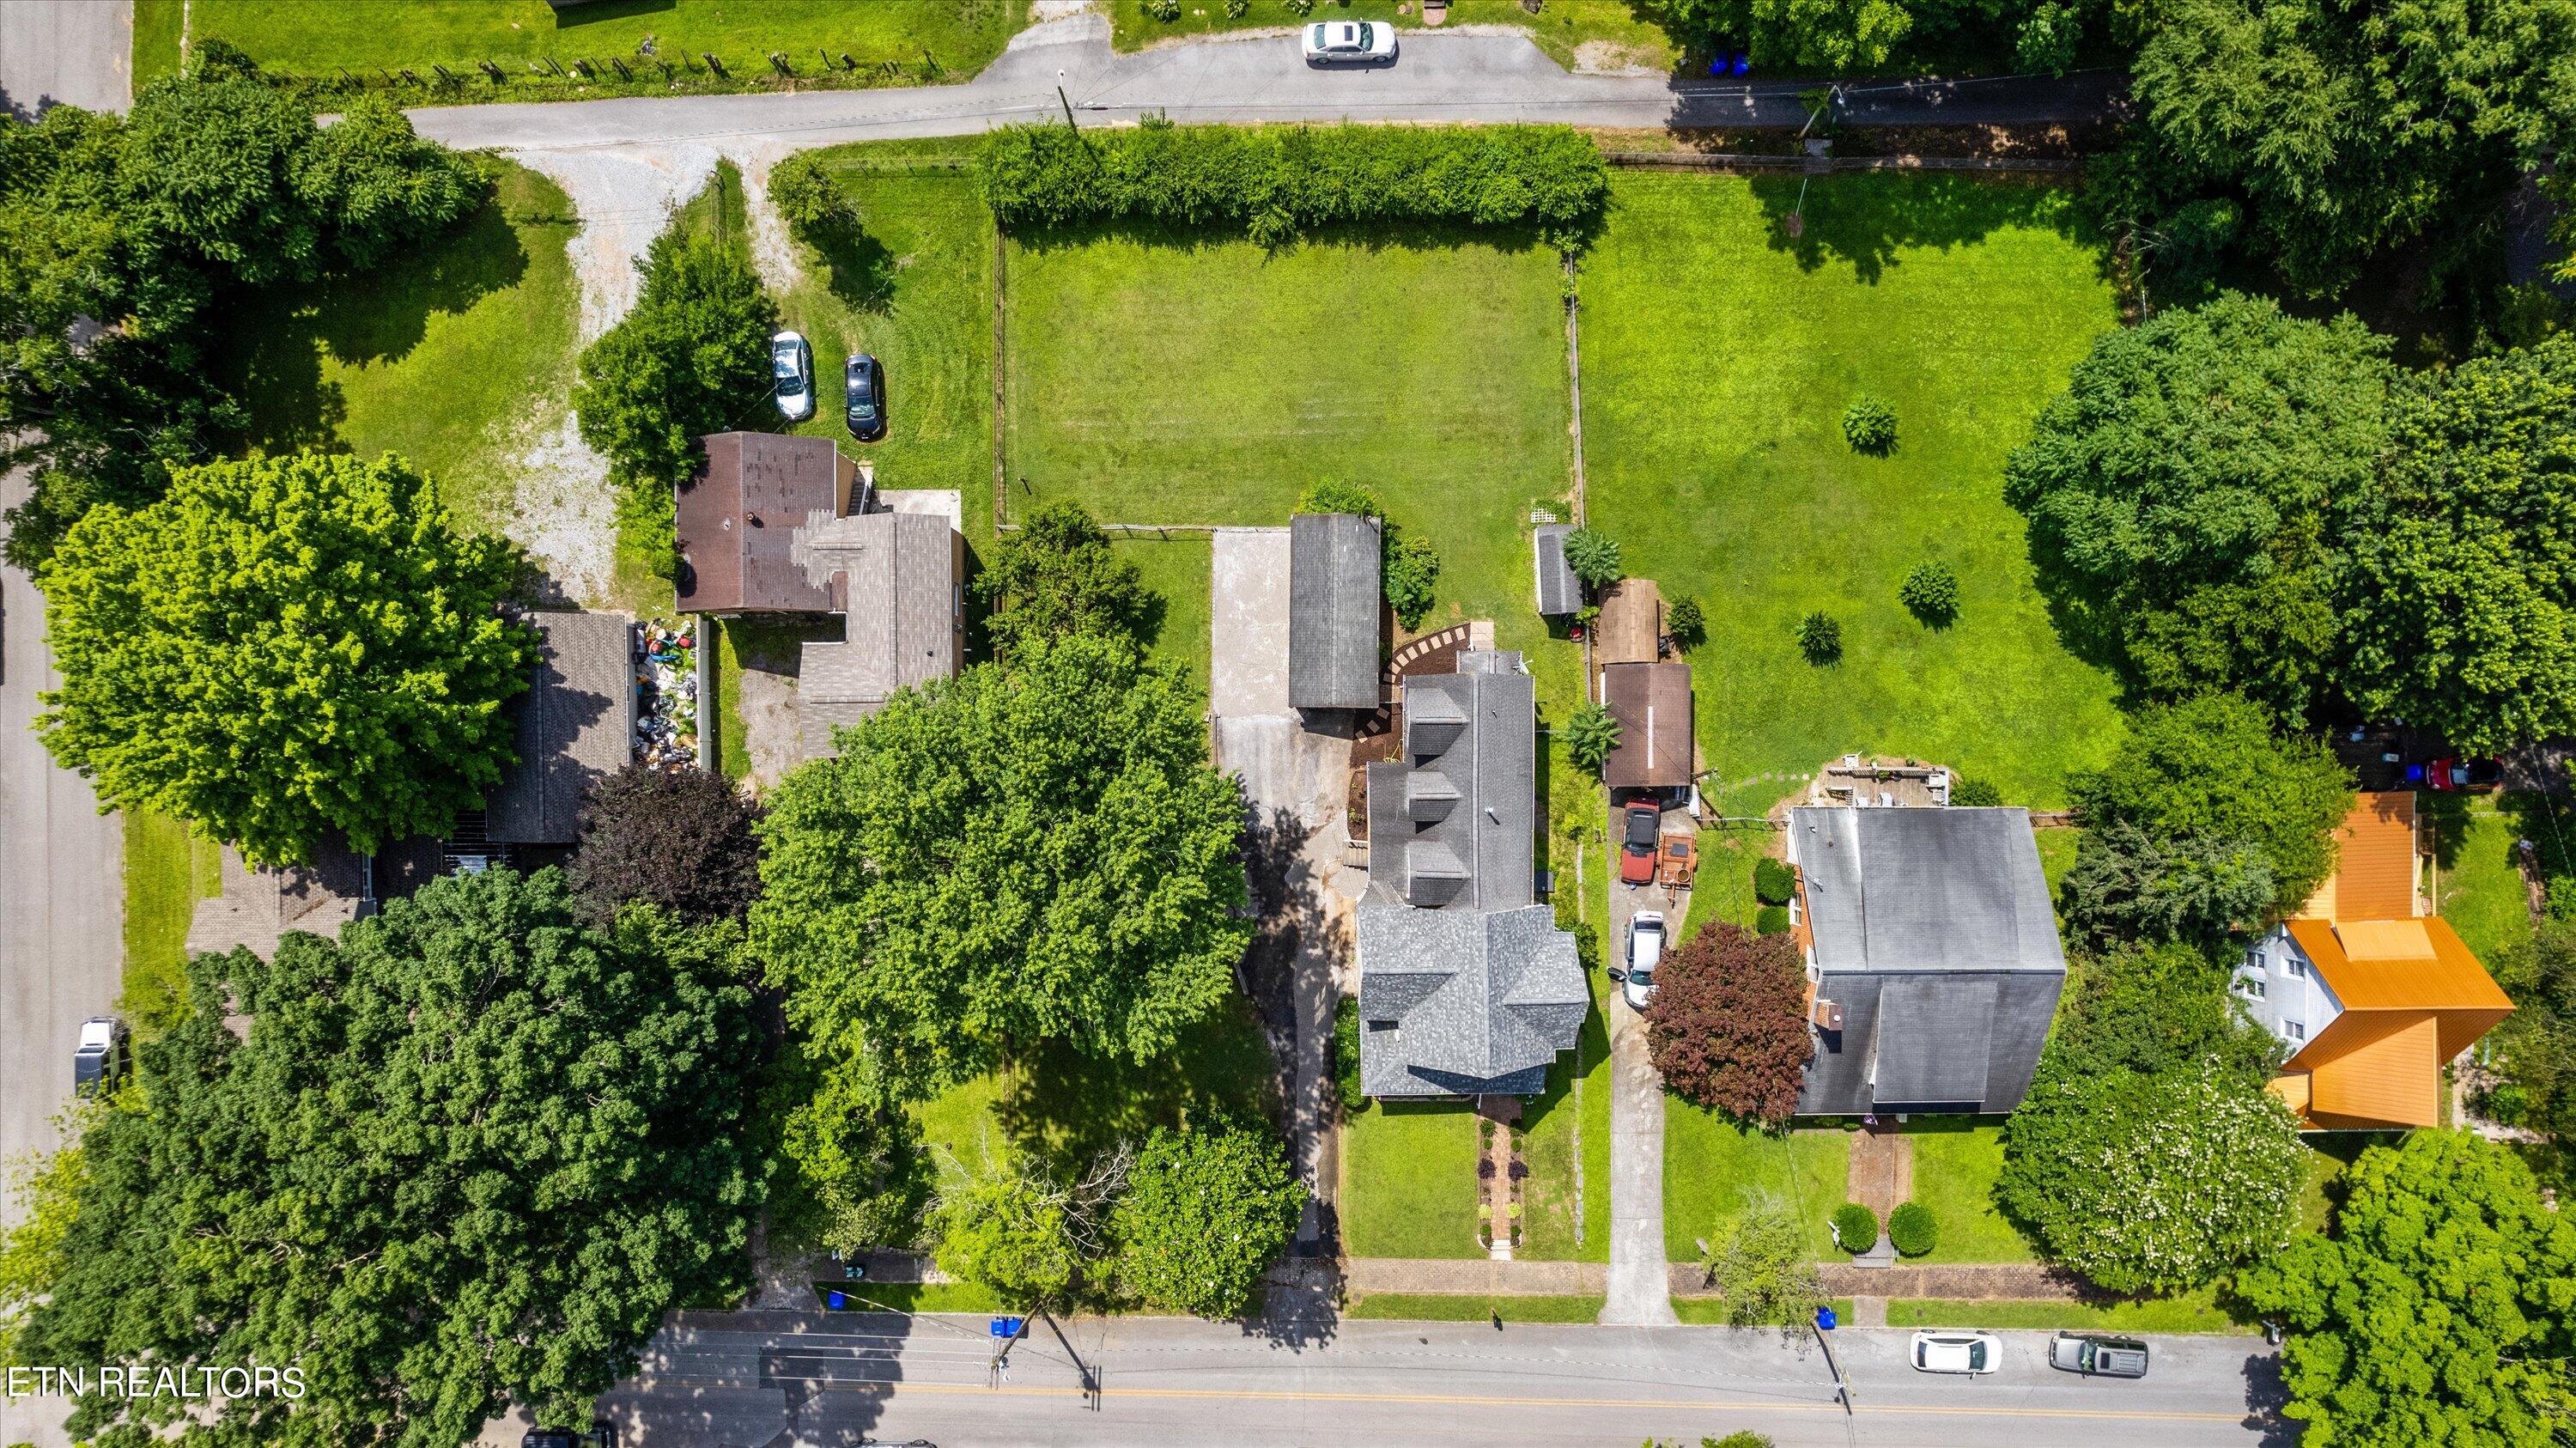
xmin=1110 ymin=1126 xmax=1306 ymax=1317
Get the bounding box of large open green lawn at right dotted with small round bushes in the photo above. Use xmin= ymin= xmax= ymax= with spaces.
xmin=1582 ymin=173 xmax=2120 ymax=814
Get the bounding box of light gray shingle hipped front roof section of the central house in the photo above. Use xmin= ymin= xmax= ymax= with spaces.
xmin=1358 ymin=902 xmax=1592 ymax=1098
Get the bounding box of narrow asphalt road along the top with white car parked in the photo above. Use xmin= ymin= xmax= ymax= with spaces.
xmin=412 ymin=15 xmax=2125 ymax=149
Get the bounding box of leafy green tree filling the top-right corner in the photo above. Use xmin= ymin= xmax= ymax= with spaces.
xmin=2130 ymin=0 xmax=2576 ymax=296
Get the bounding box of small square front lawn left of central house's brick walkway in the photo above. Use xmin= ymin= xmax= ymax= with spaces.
xmin=1340 ymin=1100 xmax=1484 ymax=1257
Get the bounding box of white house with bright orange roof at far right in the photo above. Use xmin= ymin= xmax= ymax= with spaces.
xmin=2233 ymin=794 xmax=2514 ymax=1131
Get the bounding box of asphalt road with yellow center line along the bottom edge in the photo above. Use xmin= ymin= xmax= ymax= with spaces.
xmin=518 ymin=1311 xmax=2287 ymax=1448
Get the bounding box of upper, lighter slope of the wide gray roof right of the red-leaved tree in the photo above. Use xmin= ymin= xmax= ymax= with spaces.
xmin=1788 ymin=806 xmax=2066 ymax=974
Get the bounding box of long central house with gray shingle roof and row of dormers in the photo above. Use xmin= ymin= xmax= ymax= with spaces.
xmin=1358 ymin=649 xmax=1592 ymax=1100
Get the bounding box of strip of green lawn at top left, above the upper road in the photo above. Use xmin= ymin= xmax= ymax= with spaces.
xmin=184 ymin=0 xmax=1028 ymax=75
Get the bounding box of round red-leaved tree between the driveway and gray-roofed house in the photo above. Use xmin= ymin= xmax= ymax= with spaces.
xmin=1646 ymin=922 xmax=1814 ymax=1126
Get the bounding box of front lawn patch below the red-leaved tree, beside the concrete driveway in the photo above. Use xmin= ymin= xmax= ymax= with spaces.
xmin=1664 ymin=1108 xmax=1852 ymax=1262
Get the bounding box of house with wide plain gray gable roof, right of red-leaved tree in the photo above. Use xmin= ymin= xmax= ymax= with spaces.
xmin=1788 ymin=809 xmax=2066 ymax=1116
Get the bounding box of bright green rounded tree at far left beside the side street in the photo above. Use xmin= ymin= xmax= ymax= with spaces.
xmin=36 ymin=453 xmax=533 ymax=863
